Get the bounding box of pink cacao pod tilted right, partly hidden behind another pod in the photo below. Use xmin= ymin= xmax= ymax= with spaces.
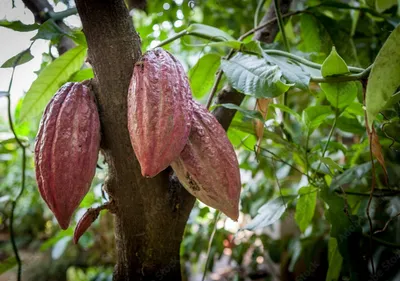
xmin=171 ymin=102 xmax=241 ymax=220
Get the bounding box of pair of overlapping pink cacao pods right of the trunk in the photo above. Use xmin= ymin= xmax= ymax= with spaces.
xmin=128 ymin=48 xmax=241 ymax=220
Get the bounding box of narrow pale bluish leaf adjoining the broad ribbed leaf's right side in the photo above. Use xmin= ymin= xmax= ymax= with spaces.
xmin=263 ymin=53 xmax=310 ymax=91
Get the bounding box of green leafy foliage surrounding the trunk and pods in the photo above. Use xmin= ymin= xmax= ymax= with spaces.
xmin=0 ymin=0 xmax=400 ymax=280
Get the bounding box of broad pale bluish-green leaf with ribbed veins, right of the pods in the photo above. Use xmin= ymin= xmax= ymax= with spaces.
xmin=221 ymin=54 xmax=294 ymax=98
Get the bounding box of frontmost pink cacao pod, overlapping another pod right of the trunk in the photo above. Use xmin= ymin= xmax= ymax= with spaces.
xmin=128 ymin=48 xmax=192 ymax=177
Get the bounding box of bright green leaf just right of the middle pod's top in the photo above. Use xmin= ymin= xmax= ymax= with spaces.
xmin=188 ymin=54 xmax=221 ymax=99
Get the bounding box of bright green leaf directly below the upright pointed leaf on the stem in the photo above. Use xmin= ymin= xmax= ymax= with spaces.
xmin=321 ymin=81 xmax=357 ymax=108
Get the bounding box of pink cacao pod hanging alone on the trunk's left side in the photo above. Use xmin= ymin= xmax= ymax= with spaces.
xmin=35 ymin=83 xmax=100 ymax=229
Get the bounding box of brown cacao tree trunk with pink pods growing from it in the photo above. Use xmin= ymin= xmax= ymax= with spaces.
xmin=76 ymin=0 xmax=194 ymax=281
